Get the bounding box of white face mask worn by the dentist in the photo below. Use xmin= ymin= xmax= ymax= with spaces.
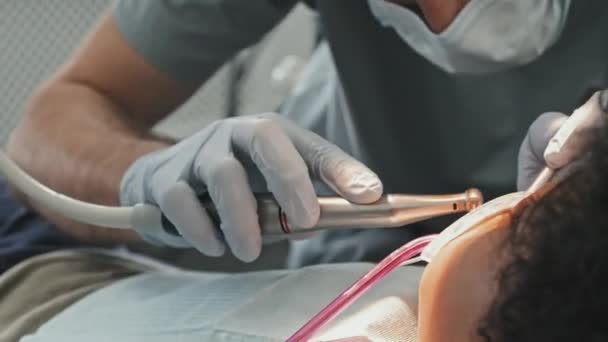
xmin=368 ymin=0 xmax=571 ymax=73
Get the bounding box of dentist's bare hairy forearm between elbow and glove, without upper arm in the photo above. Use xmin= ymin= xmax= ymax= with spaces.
xmin=8 ymin=82 xmax=170 ymax=243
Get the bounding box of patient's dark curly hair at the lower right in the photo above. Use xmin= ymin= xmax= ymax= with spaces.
xmin=477 ymin=119 xmax=608 ymax=342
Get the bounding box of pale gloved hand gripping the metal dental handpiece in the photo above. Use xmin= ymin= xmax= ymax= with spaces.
xmin=120 ymin=113 xmax=382 ymax=261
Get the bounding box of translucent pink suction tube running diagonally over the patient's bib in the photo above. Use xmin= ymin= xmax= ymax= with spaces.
xmin=287 ymin=235 xmax=436 ymax=342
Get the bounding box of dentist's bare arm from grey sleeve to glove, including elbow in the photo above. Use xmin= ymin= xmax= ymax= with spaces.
xmin=8 ymin=14 xmax=197 ymax=243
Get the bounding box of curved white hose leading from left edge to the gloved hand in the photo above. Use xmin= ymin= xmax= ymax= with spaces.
xmin=0 ymin=151 xmax=162 ymax=234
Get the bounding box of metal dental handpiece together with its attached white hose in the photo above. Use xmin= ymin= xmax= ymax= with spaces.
xmin=0 ymin=152 xmax=483 ymax=241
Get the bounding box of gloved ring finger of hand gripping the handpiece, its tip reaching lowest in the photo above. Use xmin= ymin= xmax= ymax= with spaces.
xmin=197 ymin=156 xmax=262 ymax=262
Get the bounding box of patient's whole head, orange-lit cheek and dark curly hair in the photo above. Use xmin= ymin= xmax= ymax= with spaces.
xmin=419 ymin=119 xmax=608 ymax=342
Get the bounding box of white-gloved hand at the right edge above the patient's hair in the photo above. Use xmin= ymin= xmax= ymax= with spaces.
xmin=517 ymin=90 xmax=608 ymax=190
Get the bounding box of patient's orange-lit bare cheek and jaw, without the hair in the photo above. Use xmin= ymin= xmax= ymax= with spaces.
xmin=418 ymin=214 xmax=511 ymax=342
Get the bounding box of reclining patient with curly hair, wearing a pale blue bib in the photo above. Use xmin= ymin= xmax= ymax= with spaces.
xmin=0 ymin=111 xmax=608 ymax=342
